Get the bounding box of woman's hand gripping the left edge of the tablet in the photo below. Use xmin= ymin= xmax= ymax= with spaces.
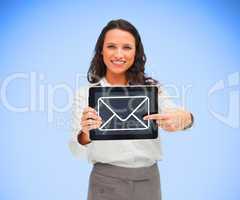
xmin=81 ymin=107 xmax=102 ymax=139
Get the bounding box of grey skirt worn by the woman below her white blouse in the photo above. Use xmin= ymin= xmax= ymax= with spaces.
xmin=88 ymin=163 xmax=161 ymax=200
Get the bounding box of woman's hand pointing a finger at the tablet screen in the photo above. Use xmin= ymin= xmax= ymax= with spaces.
xmin=143 ymin=109 xmax=192 ymax=132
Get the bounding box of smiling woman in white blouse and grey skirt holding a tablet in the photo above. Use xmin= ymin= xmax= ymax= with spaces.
xmin=73 ymin=19 xmax=193 ymax=200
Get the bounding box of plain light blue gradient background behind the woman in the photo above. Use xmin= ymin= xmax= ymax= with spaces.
xmin=0 ymin=0 xmax=240 ymax=200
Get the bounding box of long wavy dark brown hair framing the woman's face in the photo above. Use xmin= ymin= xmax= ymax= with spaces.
xmin=87 ymin=19 xmax=158 ymax=85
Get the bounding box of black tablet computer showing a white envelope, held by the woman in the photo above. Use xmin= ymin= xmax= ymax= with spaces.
xmin=88 ymin=86 xmax=158 ymax=140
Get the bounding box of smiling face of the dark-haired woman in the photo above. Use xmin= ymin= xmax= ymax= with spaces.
xmin=102 ymin=29 xmax=136 ymax=75
